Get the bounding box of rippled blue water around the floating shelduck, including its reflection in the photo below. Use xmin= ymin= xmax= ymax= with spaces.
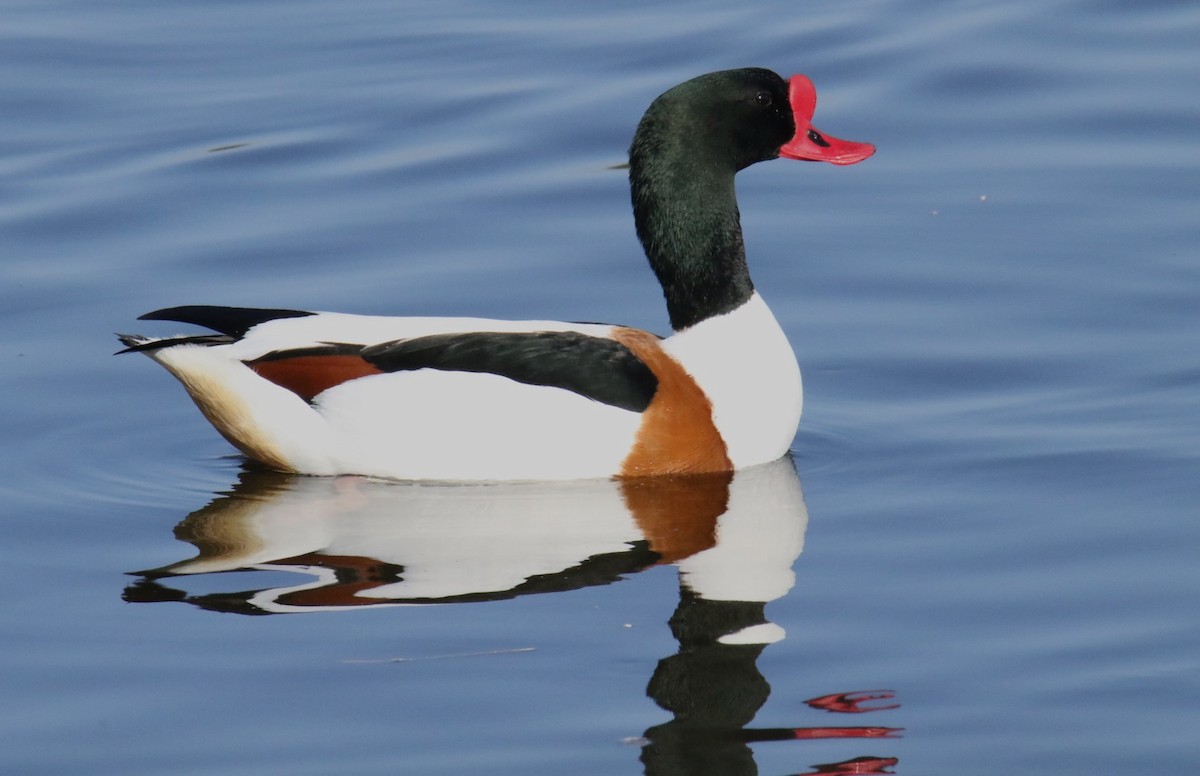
xmin=0 ymin=0 xmax=1200 ymax=775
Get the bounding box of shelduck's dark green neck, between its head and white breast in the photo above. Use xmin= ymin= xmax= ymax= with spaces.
xmin=629 ymin=153 xmax=754 ymax=331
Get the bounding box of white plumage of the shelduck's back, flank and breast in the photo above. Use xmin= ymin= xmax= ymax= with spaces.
xmin=136 ymin=294 xmax=802 ymax=480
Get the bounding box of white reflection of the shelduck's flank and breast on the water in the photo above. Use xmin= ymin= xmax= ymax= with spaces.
xmin=157 ymin=458 xmax=808 ymax=612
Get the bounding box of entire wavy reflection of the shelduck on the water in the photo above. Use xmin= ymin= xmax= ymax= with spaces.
xmin=126 ymin=458 xmax=895 ymax=776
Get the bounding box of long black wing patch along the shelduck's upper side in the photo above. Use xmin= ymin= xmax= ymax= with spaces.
xmin=360 ymin=331 xmax=659 ymax=413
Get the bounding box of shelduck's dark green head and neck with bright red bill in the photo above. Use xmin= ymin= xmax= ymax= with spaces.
xmin=629 ymin=67 xmax=875 ymax=331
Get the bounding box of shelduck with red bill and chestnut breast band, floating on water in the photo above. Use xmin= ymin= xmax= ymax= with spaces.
xmin=118 ymin=67 xmax=875 ymax=481
